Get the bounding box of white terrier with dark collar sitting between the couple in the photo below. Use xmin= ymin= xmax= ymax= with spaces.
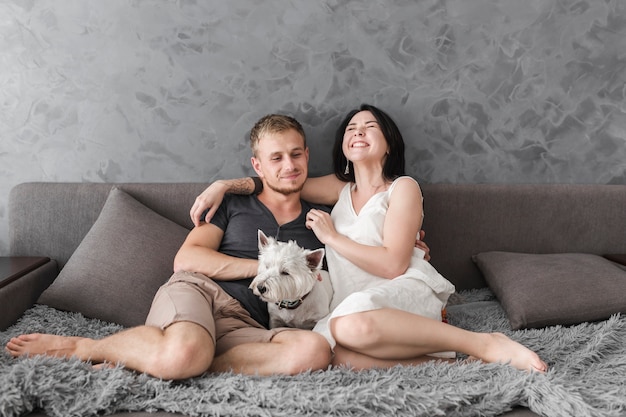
xmin=250 ymin=230 xmax=333 ymax=329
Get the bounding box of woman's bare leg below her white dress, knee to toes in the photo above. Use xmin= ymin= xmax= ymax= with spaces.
xmin=330 ymin=309 xmax=547 ymax=372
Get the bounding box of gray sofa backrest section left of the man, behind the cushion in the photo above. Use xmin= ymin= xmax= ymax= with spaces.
xmin=9 ymin=182 xmax=206 ymax=268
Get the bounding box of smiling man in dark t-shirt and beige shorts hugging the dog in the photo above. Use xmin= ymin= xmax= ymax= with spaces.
xmin=6 ymin=115 xmax=331 ymax=379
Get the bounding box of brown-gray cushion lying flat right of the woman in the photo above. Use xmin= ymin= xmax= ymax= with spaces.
xmin=473 ymin=252 xmax=626 ymax=329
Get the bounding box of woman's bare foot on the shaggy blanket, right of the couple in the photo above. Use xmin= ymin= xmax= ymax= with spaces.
xmin=480 ymin=333 xmax=548 ymax=373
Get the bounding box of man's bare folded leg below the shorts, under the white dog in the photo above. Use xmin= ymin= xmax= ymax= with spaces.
xmin=210 ymin=329 xmax=331 ymax=375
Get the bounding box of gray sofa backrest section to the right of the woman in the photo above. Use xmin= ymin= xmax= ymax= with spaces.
xmin=422 ymin=184 xmax=626 ymax=289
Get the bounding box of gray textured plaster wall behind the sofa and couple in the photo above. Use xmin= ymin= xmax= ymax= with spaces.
xmin=0 ymin=0 xmax=626 ymax=254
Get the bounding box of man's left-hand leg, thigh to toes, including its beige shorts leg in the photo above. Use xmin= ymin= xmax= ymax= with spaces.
xmin=7 ymin=272 xmax=221 ymax=379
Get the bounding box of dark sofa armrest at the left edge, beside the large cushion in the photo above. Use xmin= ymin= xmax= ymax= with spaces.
xmin=0 ymin=260 xmax=59 ymax=330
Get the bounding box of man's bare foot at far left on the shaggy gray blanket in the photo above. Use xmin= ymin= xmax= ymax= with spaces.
xmin=6 ymin=333 xmax=82 ymax=358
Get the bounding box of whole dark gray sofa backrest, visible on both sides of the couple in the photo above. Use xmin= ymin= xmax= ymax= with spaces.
xmin=9 ymin=183 xmax=626 ymax=289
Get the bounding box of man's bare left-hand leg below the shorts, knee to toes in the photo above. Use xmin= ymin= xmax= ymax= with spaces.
xmin=6 ymin=322 xmax=215 ymax=379
